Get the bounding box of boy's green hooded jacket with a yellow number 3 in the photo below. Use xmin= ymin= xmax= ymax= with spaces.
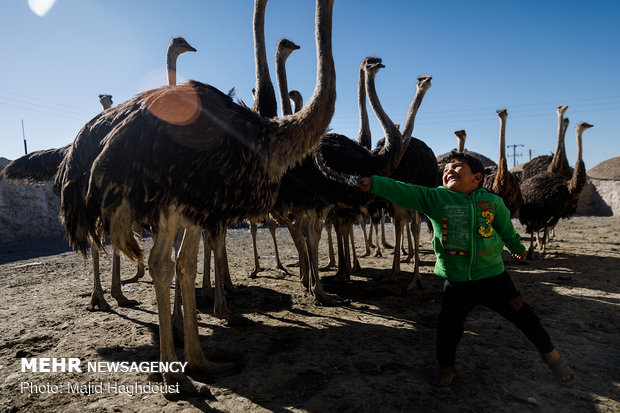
xmin=370 ymin=175 xmax=525 ymax=281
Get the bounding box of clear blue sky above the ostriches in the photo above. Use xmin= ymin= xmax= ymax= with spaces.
xmin=0 ymin=0 xmax=620 ymax=169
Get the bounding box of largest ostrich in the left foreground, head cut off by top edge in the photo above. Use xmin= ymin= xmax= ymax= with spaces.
xmin=60 ymin=0 xmax=336 ymax=392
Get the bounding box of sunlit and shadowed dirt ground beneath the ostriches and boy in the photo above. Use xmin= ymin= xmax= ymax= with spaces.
xmin=0 ymin=217 xmax=620 ymax=413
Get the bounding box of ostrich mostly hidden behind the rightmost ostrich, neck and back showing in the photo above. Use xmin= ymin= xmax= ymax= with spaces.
xmin=521 ymin=105 xmax=573 ymax=181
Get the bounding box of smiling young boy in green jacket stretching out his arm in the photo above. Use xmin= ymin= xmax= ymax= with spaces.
xmin=357 ymin=152 xmax=575 ymax=387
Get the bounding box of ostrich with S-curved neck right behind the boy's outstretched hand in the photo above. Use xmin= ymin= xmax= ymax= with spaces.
xmin=276 ymin=58 xmax=402 ymax=296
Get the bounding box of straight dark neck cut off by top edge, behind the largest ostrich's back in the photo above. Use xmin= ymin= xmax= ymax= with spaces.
xmin=252 ymin=0 xmax=278 ymax=118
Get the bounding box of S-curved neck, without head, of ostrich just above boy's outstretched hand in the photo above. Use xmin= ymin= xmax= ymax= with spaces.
xmin=366 ymin=67 xmax=403 ymax=175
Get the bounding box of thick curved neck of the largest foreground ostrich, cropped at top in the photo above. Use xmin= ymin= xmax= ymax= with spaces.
xmin=269 ymin=0 xmax=336 ymax=173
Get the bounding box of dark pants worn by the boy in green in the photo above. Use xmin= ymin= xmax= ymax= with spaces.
xmin=437 ymin=272 xmax=554 ymax=367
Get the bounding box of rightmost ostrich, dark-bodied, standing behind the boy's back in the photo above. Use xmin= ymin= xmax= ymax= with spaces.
xmin=519 ymin=122 xmax=593 ymax=258
